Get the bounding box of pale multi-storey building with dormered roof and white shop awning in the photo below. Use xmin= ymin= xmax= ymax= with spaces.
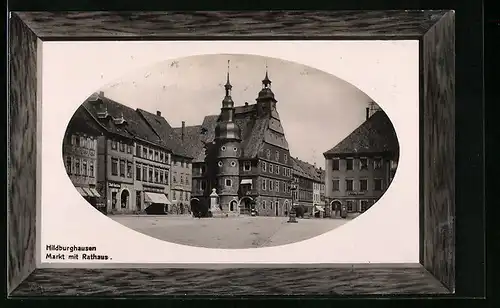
xmin=73 ymin=93 xmax=190 ymax=213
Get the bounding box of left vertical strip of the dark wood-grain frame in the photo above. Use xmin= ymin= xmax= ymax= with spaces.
xmin=7 ymin=16 xmax=37 ymax=292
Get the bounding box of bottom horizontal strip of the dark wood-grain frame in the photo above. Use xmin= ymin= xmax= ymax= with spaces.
xmin=12 ymin=265 xmax=449 ymax=297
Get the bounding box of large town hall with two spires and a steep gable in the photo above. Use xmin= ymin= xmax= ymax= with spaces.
xmin=176 ymin=65 xmax=292 ymax=216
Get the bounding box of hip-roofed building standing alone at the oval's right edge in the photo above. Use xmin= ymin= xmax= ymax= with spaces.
xmin=323 ymin=104 xmax=399 ymax=212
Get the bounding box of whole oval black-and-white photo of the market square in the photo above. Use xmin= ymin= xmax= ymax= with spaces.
xmin=63 ymin=54 xmax=399 ymax=249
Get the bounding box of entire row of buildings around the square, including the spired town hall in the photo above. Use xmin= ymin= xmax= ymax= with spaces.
xmin=63 ymin=63 xmax=398 ymax=217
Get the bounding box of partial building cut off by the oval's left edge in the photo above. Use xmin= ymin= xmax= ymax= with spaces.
xmin=63 ymin=109 xmax=104 ymax=211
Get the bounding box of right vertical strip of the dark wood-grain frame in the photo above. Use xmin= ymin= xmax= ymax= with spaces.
xmin=422 ymin=12 xmax=455 ymax=291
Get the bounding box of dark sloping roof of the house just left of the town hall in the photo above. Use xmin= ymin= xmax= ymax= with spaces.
xmin=137 ymin=109 xmax=193 ymax=158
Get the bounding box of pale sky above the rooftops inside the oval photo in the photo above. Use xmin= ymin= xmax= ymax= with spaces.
xmin=99 ymin=54 xmax=371 ymax=168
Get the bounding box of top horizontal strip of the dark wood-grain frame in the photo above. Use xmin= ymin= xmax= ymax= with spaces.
xmin=16 ymin=10 xmax=446 ymax=40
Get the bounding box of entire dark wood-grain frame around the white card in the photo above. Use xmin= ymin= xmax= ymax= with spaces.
xmin=7 ymin=10 xmax=456 ymax=297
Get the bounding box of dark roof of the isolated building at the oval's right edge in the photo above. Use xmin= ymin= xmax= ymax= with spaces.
xmin=323 ymin=110 xmax=399 ymax=158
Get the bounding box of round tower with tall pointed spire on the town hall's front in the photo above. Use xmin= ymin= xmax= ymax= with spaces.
xmin=215 ymin=61 xmax=241 ymax=212
